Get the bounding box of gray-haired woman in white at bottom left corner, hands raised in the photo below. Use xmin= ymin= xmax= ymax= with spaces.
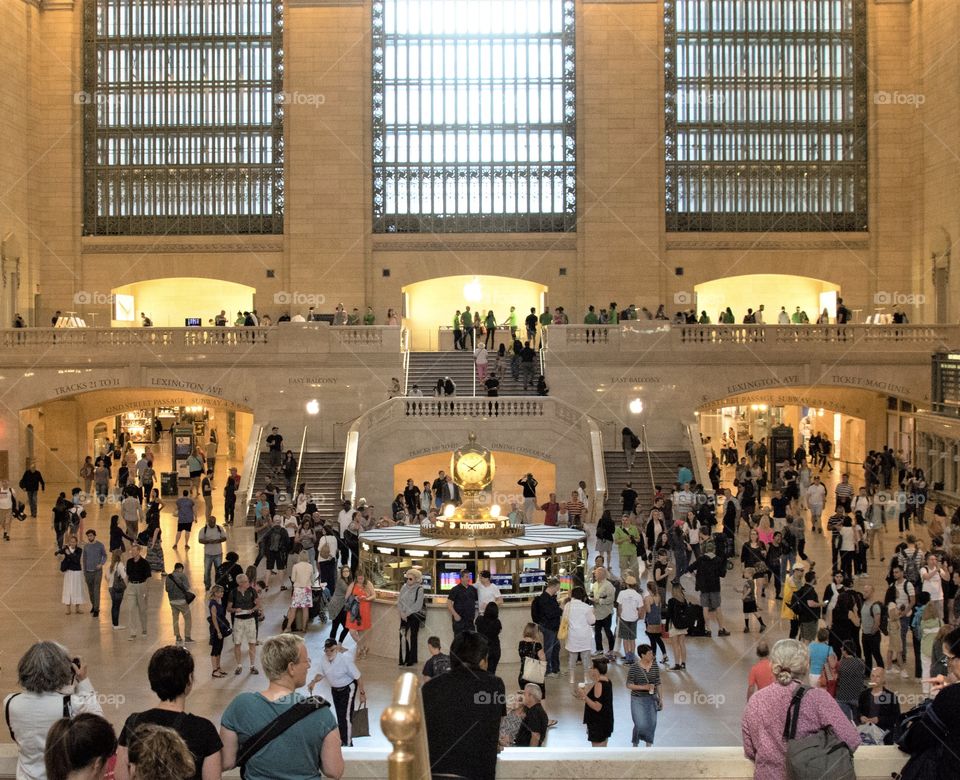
xmin=4 ymin=641 xmax=103 ymax=780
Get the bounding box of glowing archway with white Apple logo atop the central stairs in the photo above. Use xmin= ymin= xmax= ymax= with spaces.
xmin=403 ymin=274 xmax=547 ymax=351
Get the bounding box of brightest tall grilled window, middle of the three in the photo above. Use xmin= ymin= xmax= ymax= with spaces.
xmin=372 ymin=0 xmax=577 ymax=233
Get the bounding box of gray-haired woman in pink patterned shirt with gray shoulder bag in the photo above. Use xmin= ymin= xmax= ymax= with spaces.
xmin=741 ymin=639 xmax=860 ymax=780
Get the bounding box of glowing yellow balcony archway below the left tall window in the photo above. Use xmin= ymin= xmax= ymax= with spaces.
xmin=111 ymin=277 xmax=256 ymax=328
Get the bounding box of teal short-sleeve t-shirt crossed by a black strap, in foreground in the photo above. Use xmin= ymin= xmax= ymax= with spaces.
xmin=220 ymin=693 xmax=337 ymax=780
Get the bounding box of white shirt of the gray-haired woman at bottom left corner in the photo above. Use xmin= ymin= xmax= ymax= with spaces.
xmin=4 ymin=680 xmax=103 ymax=780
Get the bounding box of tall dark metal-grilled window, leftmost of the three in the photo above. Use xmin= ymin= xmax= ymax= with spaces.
xmin=83 ymin=0 xmax=284 ymax=236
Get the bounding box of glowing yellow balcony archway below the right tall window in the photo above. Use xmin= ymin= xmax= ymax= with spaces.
xmin=694 ymin=274 xmax=840 ymax=324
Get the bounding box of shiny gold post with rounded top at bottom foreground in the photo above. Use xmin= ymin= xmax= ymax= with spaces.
xmin=380 ymin=672 xmax=430 ymax=780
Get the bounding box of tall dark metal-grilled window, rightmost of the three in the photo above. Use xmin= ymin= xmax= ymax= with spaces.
xmin=664 ymin=0 xmax=868 ymax=232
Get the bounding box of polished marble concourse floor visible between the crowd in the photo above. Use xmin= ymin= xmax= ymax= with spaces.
xmin=0 ymin=463 xmax=920 ymax=747
